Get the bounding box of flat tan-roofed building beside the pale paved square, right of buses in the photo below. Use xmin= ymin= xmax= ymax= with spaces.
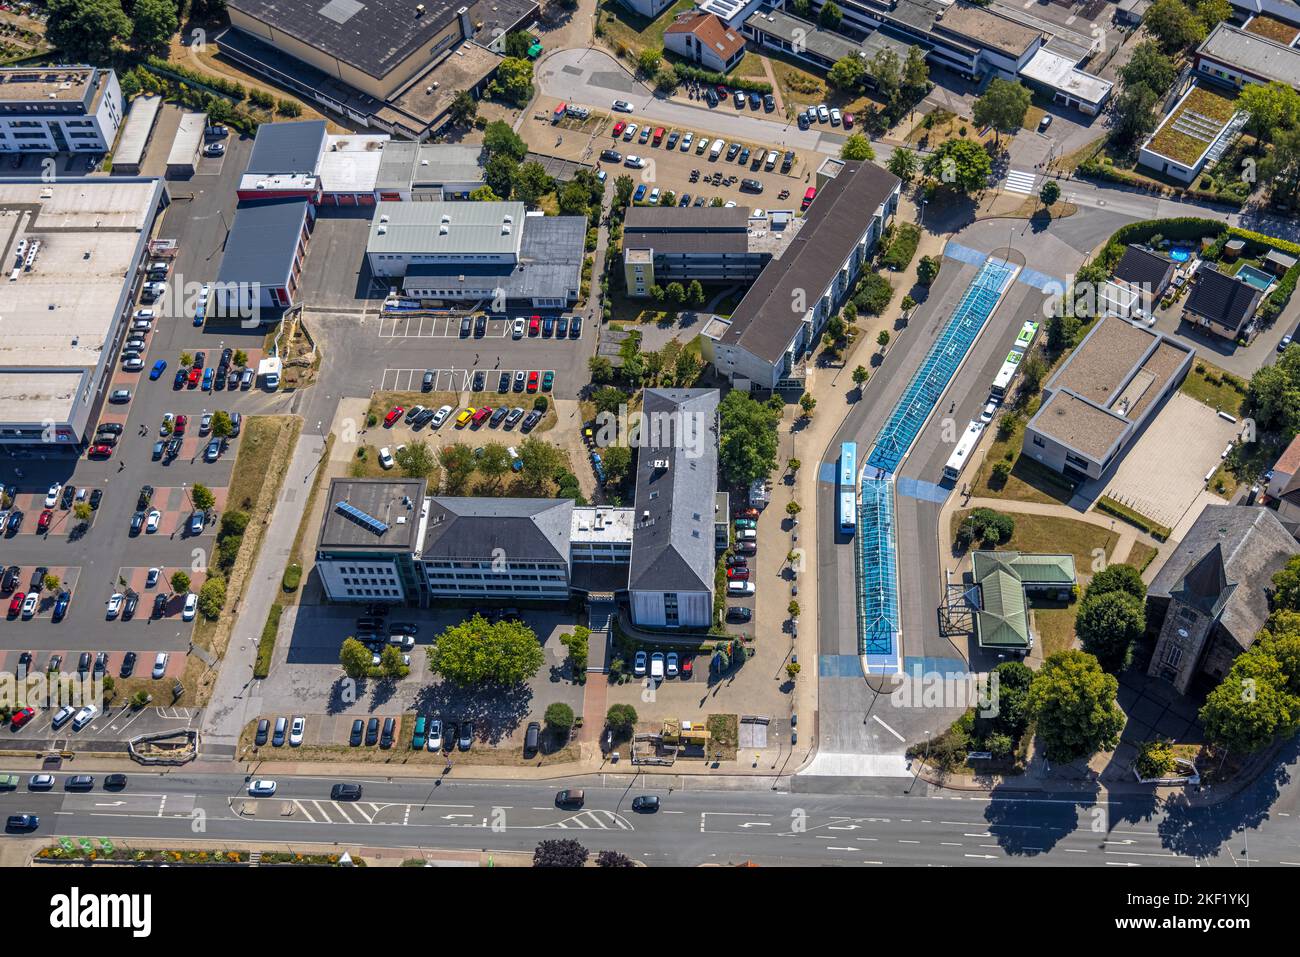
xmin=1023 ymin=316 xmax=1195 ymax=480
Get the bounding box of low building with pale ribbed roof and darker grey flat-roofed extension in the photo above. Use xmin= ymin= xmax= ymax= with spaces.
xmin=365 ymin=202 xmax=586 ymax=309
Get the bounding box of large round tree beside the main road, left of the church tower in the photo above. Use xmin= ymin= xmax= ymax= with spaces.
xmin=1030 ymin=649 xmax=1125 ymax=765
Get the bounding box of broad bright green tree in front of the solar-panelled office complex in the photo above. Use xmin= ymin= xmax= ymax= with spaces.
xmin=428 ymin=615 xmax=545 ymax=687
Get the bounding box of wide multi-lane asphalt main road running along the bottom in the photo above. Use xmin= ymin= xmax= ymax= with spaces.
xmin=0 ymin=746 xmax=1300 ymax=867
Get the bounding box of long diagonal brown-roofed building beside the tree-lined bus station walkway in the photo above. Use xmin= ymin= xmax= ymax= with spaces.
xmin=701 ymin=160 xmax=901 ymax=389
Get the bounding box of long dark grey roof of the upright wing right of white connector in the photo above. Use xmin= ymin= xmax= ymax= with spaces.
xmin=628 ymin=389 xmax=718 ymax=594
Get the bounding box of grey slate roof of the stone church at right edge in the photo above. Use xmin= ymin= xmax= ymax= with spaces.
xmin=1147 ymin=505 xmax=1300 ymax=649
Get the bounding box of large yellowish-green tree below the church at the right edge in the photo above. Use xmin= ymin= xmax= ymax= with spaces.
xmin=1200 ymin=645 xmax=1300 ymax=752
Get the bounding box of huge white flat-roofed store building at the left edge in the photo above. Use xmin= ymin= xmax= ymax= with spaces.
xmin=0 ymin=177 xmax=168 ymax=447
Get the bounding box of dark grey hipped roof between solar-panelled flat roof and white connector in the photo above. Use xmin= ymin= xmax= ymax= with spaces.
xmin=421 ymin=497 xmax=573 ymax=566
